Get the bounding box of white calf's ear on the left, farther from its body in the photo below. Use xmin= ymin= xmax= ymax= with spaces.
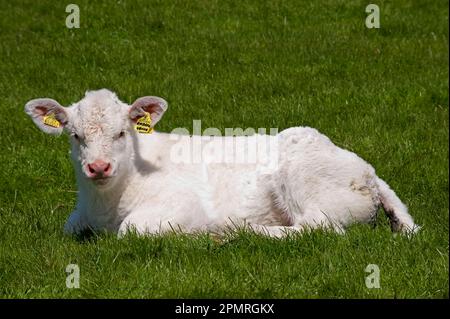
xmin=25 ymin=99 xmax=68 ymax=135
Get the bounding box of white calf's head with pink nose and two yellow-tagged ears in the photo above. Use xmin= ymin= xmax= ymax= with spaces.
xmin=25 ymin=89 xmax=167 ymax=187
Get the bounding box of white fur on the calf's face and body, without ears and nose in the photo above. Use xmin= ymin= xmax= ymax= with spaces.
xmin=27 ymin=90 xmax=418 ymax=237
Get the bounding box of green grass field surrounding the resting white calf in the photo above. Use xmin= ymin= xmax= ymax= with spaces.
xmin=0 ymin=0 xmax=449 ymax=298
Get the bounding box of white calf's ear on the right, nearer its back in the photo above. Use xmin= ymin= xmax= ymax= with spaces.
xmin=129 ymin=96 xmax=168 ymax=127
